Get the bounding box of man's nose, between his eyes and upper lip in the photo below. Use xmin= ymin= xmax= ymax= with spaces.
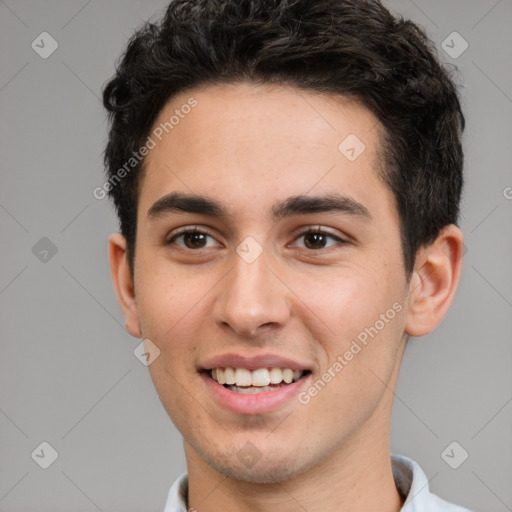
xmin=214 ymin=245 xmax=290 ymax=338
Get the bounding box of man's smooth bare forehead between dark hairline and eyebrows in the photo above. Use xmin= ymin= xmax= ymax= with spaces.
xmin=136 ymin=83 xmax=392 ymax=222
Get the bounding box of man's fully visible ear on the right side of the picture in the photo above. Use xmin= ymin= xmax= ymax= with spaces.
xmin=405 ymin=224 xmax=464 ymax=336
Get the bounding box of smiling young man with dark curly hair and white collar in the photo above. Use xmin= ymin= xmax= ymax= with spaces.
xmin=104 ymin=0 xmax=467 ymax=512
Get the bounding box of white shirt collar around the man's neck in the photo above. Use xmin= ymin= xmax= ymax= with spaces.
xmin=164 ymin=454 xmax=471 ymax=512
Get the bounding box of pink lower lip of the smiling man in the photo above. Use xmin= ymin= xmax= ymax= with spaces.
xmin=201 ymin=372 xmax=311 ymax=415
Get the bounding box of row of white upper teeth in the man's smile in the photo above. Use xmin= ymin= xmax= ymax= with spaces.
xmin=212 ymin=368 xmax=303 ymax=386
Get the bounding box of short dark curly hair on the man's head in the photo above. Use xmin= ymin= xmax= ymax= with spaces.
xmin=103 ymin=0 xmax=465 ymax=277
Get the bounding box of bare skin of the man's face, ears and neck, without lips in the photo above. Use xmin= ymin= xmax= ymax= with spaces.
xmin=110 ymin=83 xmax=463 ymax=512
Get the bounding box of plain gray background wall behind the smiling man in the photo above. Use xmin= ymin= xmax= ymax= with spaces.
xmin=0 ymin=0 xmax=512 ymax=512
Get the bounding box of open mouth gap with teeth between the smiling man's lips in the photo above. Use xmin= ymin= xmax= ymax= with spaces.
xmin=206 ymin=367 xmax=311 ymax=394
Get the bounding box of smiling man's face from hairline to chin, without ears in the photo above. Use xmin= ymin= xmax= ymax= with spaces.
xmin=132 ymin=84 xmax=407 ymax=482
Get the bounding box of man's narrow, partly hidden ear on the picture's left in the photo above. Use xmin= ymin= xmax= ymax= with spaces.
xmin=109 ymin=233 xmax=142 ymax=338
